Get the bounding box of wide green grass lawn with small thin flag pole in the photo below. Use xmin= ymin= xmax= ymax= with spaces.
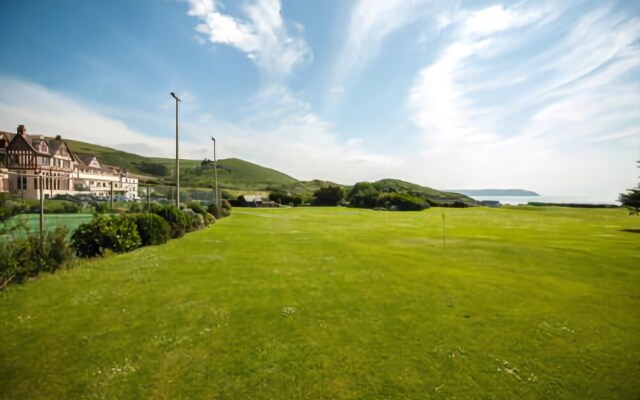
xmin=0 ymin=207 xmax=640 ymax=399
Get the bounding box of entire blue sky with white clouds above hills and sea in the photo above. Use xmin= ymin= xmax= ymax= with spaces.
xmin=0 ymin=0 xmax=640 ymax=201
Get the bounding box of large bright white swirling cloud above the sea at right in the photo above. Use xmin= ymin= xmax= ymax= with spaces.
xmin=407 ymin=6 xmax=640 ymax=200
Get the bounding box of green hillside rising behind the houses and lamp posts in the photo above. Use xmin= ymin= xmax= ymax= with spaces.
xmin=65 ymin=139 xmax=474 ymax=203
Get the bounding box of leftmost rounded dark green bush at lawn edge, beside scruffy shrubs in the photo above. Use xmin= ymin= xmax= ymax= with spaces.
xmin=71 ymin=215 xmax=141 ymax=258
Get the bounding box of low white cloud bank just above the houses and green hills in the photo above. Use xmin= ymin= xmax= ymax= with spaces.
xmin=0 ymin=76 xmax=400 ymax=183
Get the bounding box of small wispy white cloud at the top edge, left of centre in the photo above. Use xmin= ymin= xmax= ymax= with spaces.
xmin=188 ymin=0 xmax=311 ymax=79
